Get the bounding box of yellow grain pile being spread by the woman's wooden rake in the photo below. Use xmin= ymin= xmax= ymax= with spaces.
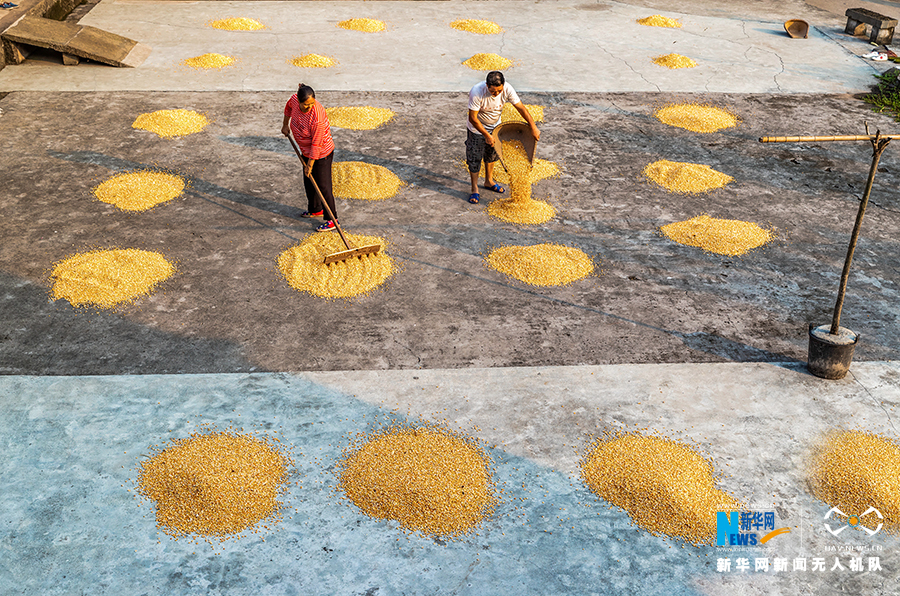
xmin=278 ymin=231 xmax=394 ymax=298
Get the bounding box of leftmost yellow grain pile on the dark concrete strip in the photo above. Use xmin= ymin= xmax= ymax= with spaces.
xmin=50 ymin=248 xmax=175 ymax=308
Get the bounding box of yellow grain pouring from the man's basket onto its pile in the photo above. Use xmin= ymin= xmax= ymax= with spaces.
xmin=487 ymin=141 xmax=556 ymax=224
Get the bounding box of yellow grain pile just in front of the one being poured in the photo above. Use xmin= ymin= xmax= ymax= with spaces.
xmin=484 ymin=244 xmax=594 ymax=287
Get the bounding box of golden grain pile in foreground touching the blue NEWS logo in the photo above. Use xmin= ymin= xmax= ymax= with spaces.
xmin=581 ymin=434 xmax=740 ymax=544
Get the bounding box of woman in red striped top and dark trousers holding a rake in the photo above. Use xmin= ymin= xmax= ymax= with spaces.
xmin=281 ymin=83 xmax=337 ymax=232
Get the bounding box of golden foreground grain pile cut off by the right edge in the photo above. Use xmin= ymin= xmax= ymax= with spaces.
xmin=809 ymin=431 xmax=900 ymax=536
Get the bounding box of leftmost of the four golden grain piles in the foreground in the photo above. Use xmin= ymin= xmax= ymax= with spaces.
xmin=138 ymin=431 xmax=289 ymax=539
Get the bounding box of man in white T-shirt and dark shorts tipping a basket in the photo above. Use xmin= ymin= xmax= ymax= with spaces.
xmin=466 ymin=70 xmax=541 ymax=203
